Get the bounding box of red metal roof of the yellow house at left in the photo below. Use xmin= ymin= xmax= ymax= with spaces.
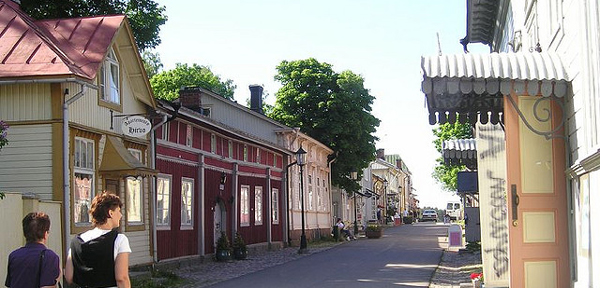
xmin=0 ymin=0 xmax=125 ymax=80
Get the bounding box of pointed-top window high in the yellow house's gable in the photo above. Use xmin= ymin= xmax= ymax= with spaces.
xmin=98 ymin=48 xmax=121 ymax=105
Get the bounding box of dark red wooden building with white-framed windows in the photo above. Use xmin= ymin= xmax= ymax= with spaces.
xmin=154 ymin=88 xmax=292 ymax=261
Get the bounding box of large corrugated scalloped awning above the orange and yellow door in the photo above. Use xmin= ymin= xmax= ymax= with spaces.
xmin=421 ymin=52 xmax=569 ymax=125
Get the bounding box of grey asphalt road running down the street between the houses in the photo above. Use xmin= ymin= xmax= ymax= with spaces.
xmin=210 ymin=223 xmax=447 ymax=288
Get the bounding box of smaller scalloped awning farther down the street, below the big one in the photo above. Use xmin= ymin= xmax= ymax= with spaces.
xmin=442 ymin=139 xmax=477 ymax=170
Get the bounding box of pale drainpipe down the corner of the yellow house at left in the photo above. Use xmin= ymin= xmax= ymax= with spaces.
xmin=63 ymin=84 xmax=87 ymax=259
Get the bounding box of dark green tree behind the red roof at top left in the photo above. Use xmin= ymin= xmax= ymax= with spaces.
xmin=21 ymin=0 xmax=167 ymax=50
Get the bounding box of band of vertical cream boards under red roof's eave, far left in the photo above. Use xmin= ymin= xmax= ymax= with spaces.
xmin=0 ymin=84 xmax=52 ymax=121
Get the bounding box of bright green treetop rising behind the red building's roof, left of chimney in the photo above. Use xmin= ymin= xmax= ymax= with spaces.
xmin=150 ymin=63 xmax=236 ymax=100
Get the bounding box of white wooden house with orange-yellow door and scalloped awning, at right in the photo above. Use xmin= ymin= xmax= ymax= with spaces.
xmin=422 ymin=0 xmax=600 ymax=288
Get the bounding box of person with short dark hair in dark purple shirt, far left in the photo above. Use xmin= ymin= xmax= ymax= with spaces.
xmin=4 ymin=212 xmax=61 ymax=288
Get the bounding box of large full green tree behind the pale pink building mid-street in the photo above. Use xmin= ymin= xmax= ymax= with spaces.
xmin=269 ymin=58 xmax=380 ymax=191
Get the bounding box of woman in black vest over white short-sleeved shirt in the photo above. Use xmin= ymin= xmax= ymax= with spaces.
xmin=65 ymin=192 xmax=131 ymax=288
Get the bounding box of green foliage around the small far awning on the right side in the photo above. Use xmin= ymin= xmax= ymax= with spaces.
xmin=432 ymin=122 xmax=473 ymax=192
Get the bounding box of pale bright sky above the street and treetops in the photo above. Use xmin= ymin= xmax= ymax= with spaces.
xmin=156 ymin=0 xmax=485 ymax=208
